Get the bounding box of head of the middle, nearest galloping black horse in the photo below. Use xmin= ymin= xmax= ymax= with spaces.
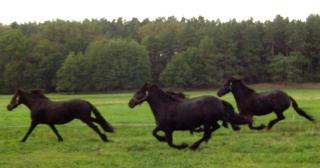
xmin=128 ymin=83 xmax=152 ymax=108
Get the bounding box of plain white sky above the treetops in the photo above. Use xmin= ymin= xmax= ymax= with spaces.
xmin=0 ymin=0 xmax=320 ymax=24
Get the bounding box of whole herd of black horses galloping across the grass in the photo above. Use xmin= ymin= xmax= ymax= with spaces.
xmin=7 ymin=77 xmax=314 ymax=150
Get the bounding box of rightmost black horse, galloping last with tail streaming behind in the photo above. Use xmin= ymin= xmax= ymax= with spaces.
xmin=218 ymin=77 xmax=314 ymax=130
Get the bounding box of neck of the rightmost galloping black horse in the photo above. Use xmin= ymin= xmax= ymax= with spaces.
xmin=232 ymin=84 xmax=255 ymax=106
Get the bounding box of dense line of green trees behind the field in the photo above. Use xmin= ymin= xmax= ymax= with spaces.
xmin=0 ymin=14 xmax=320 ymax=93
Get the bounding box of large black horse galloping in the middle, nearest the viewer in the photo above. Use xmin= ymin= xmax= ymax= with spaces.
xmin=128 ymin=84 xmax=240 ymax=149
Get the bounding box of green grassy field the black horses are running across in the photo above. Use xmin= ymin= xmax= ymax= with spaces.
xmin=0 ymin=88 xmax=320 ymax=168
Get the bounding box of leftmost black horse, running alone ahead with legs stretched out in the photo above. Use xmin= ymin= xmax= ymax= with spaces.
xmin=7 ymin=89 xmax=113 ymax=142
